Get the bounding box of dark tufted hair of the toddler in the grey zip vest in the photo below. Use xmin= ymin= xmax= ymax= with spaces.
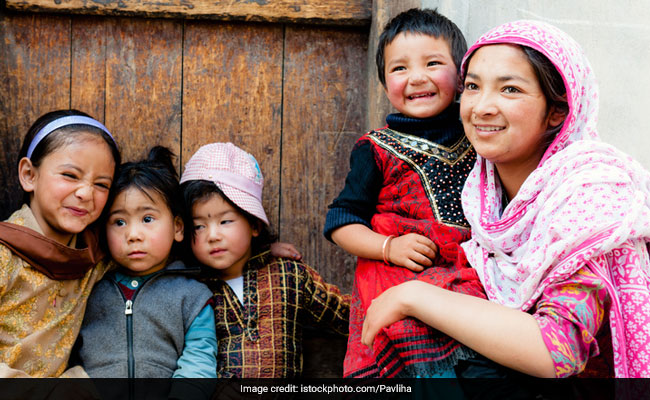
xmin=101 ymin=146 xmax=183 ymax=253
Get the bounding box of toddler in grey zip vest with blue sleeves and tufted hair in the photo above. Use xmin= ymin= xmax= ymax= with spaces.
xmin=73 ymin=146 xmax=217 ymax=396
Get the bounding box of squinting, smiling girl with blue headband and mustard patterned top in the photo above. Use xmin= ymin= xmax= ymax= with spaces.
xmin=0 ymin=110 xmax=120 ymax=377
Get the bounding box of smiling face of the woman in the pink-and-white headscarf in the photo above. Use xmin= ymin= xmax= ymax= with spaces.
xmin=460 ymin=44 xmax=564 ymax=173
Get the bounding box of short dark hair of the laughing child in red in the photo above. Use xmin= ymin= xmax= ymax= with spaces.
xmin=375 ymin=8 xmax=467 ymax=86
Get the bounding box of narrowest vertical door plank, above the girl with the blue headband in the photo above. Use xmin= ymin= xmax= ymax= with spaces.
xmin=70 ymin=17 xmax=107 ymax=122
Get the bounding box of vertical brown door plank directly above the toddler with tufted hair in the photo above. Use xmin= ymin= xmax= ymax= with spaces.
xmin=105 ymin=18 xmax=183 ymax=167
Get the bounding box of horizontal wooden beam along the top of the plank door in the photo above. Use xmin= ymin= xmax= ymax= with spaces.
xmin=6 ymin=0 xmax=371 ymax=25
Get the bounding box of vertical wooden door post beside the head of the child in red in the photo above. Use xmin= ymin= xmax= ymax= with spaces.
xmin=366 ymin=0 xmax=422 ymax=130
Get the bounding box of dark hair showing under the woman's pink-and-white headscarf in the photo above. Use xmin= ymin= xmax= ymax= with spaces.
xmin=520 ymin=46 xmax=569 ymax=148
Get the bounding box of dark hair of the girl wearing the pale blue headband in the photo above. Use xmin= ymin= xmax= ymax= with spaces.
xmin=16 ymin=109 xmax=122 ymax=203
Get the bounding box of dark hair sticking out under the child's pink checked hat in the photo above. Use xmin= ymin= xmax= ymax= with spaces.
xmin=181 ymin=180 xmax=277 ymax=260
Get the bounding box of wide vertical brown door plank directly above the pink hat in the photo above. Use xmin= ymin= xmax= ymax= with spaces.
xmin=182 ymin=21 xmax=283 ymax=229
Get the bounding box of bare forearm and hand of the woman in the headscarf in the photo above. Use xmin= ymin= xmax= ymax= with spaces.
xmin=361 ymin=281 xmax=555 ymax=378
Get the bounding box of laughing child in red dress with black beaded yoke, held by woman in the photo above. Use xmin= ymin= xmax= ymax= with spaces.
xmin=324 ymin=9 xmax=485 ymax=377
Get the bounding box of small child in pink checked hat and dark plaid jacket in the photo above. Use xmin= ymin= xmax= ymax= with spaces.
xmin=181 ymin=143 xmax=350 ymax=378
